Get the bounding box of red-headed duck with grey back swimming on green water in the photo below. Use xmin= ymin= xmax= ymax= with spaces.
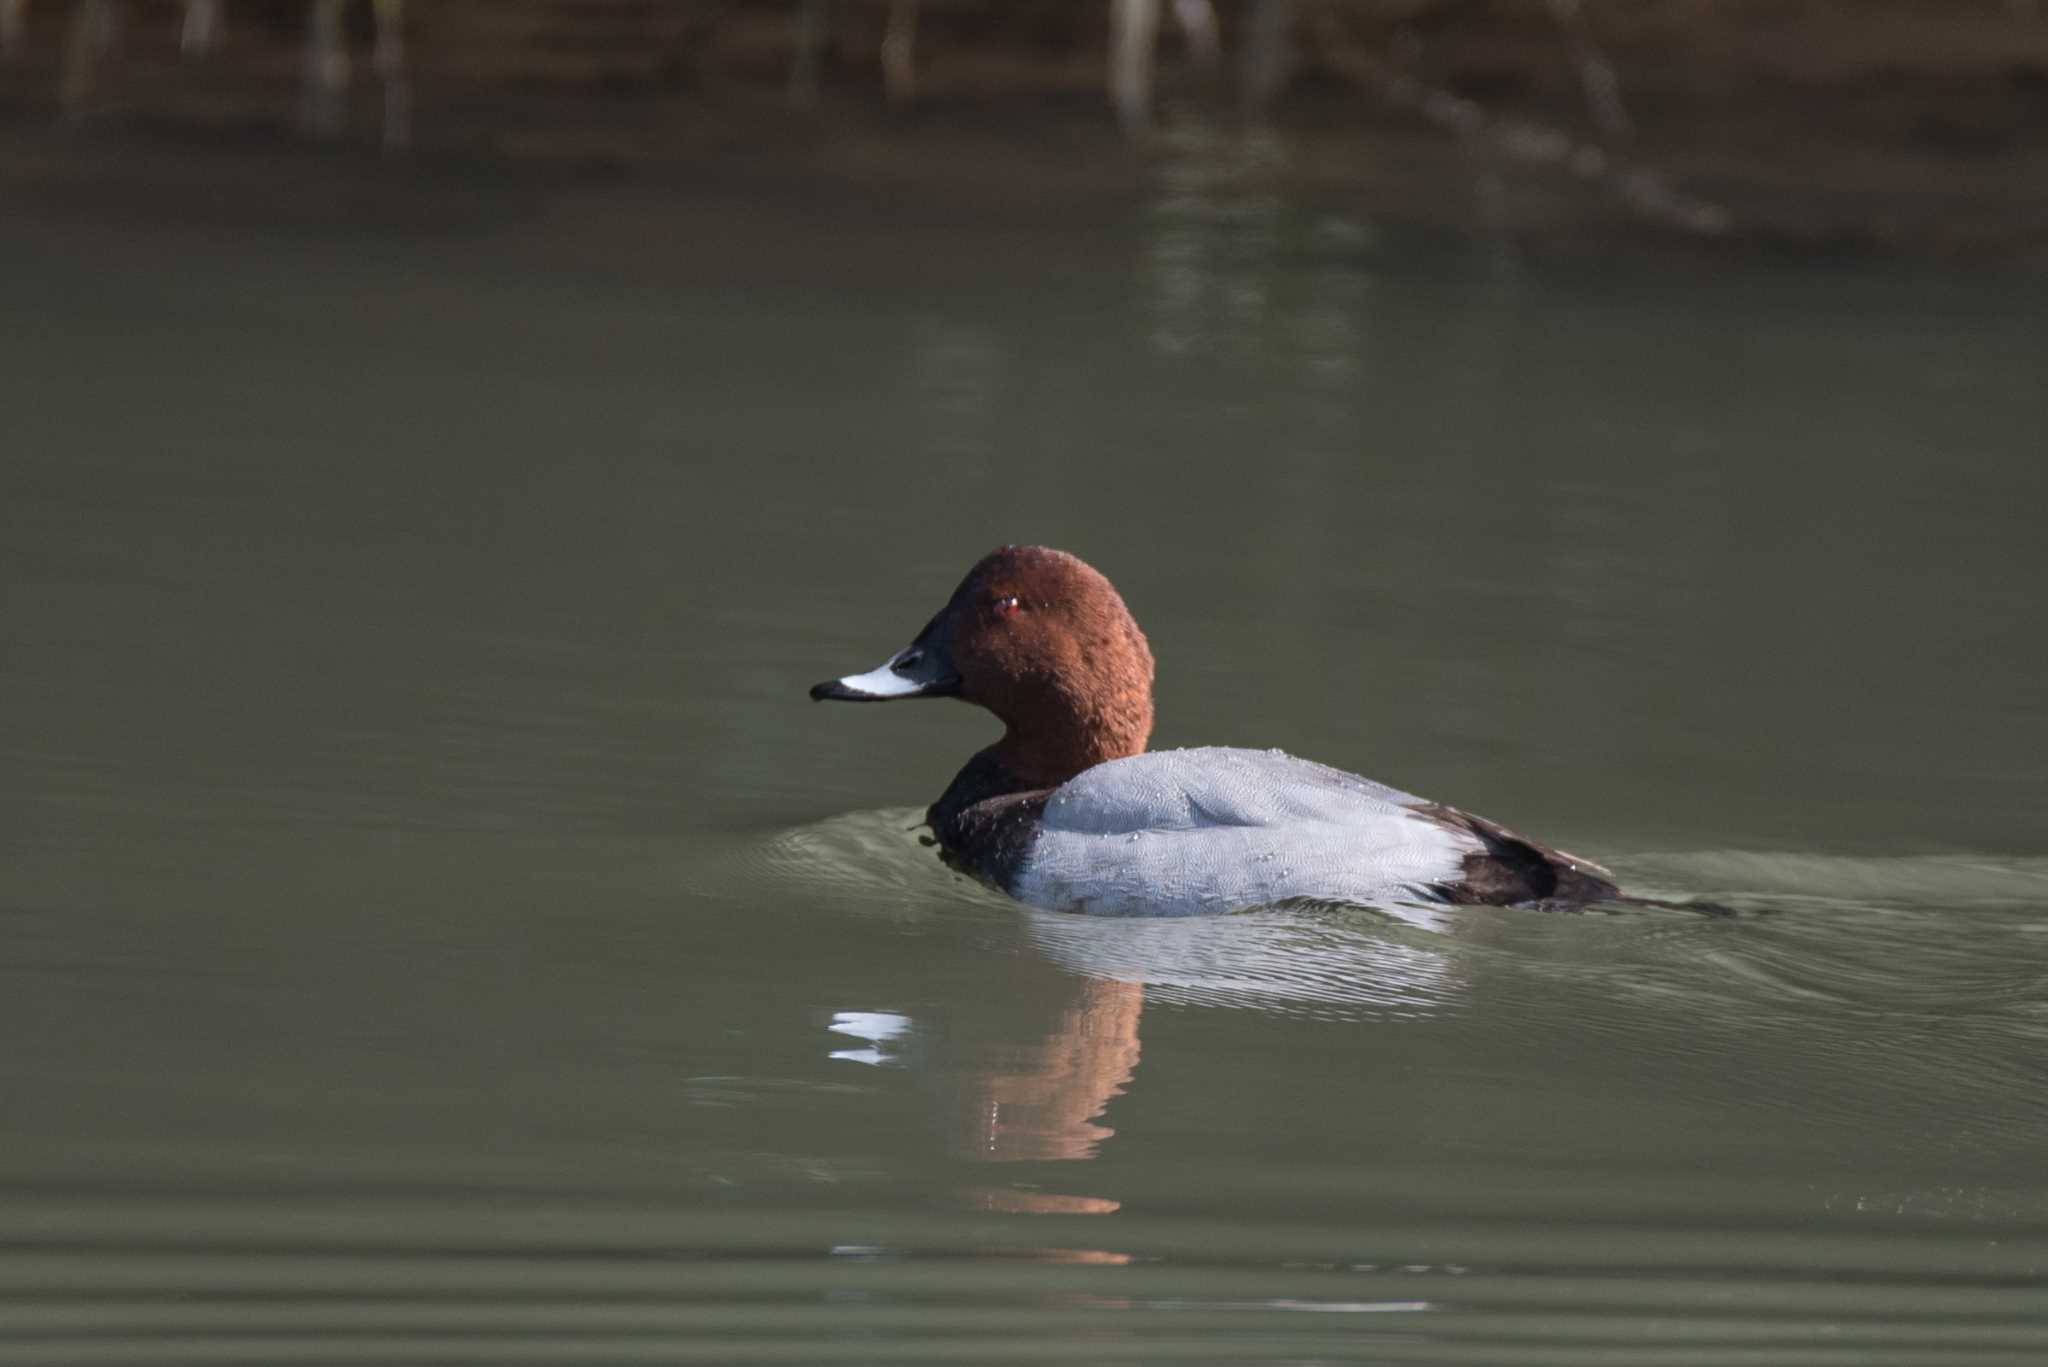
xmin=811 ymin=545 xmax=1620 ymax=916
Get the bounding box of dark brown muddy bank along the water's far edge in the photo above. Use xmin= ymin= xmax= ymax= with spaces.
xmin=0 ymin=0 xmax=2048 ymax=266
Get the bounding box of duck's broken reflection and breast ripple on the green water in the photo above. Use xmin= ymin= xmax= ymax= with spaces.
xmin=786 ymin=810 xmax=1489 ymax=1229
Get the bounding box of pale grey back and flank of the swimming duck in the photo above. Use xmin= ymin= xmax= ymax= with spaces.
xmin=1012 ymin=746 xmax=1479 ymax=916
